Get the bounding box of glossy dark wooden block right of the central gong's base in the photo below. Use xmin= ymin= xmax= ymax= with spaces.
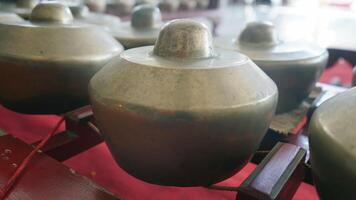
xmin=236 ymin=143 xmax=306 ymax=200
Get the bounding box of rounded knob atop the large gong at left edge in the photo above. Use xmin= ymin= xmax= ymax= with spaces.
xmin=30 ymin=2 xmax=73 ymax=23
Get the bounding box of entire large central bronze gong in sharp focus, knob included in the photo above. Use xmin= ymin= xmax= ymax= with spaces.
xmin=89 ymin=20 xmax=278 ymax=186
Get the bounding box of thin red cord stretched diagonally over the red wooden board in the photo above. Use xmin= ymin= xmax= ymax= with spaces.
xmin=0 ymin=117 xmax=64 ymax=200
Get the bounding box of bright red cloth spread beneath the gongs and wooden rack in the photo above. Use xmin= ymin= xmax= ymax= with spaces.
xmin=4 ymin=59 xmax=352 ymax=200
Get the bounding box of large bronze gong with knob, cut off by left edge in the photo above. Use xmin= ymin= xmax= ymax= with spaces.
xmin=0 ymin=3 xmax=123 ymax=113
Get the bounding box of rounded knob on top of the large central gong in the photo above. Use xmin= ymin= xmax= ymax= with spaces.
xmin=153 ymin=19 xmax=214 ymax=58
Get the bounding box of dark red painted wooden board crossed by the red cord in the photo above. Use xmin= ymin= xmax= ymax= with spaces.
xmin=0 ymin=135 xmax=117 ymax=200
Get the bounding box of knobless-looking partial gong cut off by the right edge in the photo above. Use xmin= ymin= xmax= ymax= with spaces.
xmin=309 ymin=88 xmax=356 ymax=200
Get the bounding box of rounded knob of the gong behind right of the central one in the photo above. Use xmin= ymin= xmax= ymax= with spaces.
xmin=238 ymin=22 xmax=279 ymax=46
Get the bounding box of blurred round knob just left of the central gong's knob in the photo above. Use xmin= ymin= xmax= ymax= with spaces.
xmin=131 ymin=4 xmax=162 ymax=29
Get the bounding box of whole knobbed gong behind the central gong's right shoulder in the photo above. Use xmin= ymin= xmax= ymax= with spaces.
xmin=215 ymin=22 xmax=328 ymax=113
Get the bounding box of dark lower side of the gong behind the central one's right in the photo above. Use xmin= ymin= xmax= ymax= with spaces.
xmin=255 ymin=52 xmax=328 ymax=113
